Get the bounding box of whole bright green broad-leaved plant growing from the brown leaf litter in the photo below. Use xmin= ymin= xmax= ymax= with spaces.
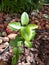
xmin=8 ymin=12 xmax=38 ymax=65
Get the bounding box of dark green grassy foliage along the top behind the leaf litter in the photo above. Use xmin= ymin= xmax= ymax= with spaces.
xmin=0 ymin=0 xmax=44 ymax=13
